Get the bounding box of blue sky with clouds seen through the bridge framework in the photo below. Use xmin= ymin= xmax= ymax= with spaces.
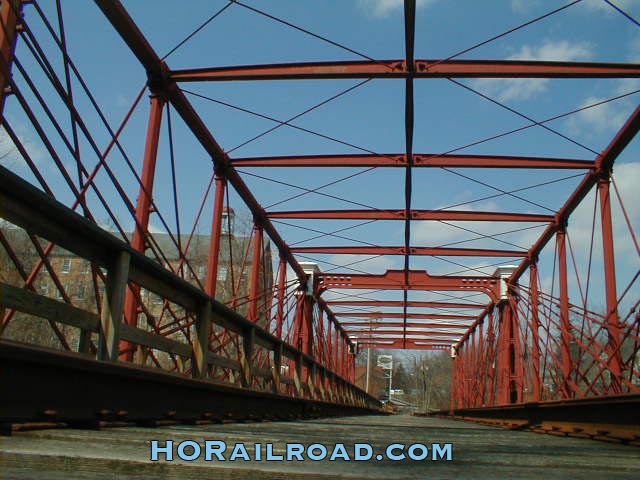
xmin=4 ymin=0 xmax=640 ymax=338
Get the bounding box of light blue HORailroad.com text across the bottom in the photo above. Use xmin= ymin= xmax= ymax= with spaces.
xmin=151 ymin=440 xmax=453 ymax=462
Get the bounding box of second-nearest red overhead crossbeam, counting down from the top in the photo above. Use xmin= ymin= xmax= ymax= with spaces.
xmin=231 ymin=153 xmax=594 ymax=169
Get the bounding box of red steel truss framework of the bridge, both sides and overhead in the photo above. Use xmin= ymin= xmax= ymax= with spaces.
xmin=0 ymin=0 xmax=640 ymax=414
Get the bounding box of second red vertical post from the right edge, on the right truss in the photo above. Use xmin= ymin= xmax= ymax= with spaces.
xmin=556 ymin=227 xmax=573 ymax=398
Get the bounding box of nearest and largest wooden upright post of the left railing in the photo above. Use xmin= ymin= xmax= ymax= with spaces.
xmin=98 ymin=252 xmax=130 ymax=362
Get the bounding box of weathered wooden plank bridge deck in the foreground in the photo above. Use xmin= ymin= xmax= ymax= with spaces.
xmin=0 ymin=415 xmax=640 ymax=480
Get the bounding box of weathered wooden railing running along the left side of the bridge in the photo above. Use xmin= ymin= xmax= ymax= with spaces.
xmin=0 ymin=162 xmax=380 ymax=420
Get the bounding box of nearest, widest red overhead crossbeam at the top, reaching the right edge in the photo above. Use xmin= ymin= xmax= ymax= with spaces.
xmin=171 ymin=60 xmax=640 ymax=82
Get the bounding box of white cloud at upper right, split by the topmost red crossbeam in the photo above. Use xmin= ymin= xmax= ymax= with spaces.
xmin=474 ymin=40 xmax=593 ymax=102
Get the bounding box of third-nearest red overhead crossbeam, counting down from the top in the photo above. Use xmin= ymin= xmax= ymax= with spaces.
xmin=267 ymin=210 xmax=554 ymax=223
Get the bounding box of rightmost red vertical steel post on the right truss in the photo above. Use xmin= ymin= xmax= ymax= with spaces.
xmin=598 ymin=173 xmax=622 ymax=394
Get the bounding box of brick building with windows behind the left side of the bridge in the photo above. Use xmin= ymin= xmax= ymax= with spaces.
xmin=0 ymin=212 xmax=273 ymax=346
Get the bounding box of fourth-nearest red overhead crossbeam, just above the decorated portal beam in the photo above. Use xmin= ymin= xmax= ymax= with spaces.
xmin=291 ymin=246 xmax=527 ymax=257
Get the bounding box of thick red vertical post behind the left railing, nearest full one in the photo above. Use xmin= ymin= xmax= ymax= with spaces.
xmin=120 ymin=93 xmax=166 ymax=362
